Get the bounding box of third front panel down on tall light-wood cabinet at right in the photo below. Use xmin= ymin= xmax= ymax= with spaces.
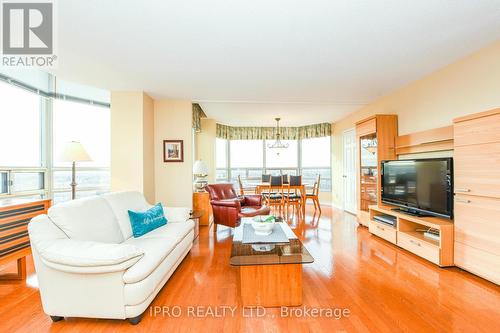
xmin=454 ymin=195 xmax=500 ymax=254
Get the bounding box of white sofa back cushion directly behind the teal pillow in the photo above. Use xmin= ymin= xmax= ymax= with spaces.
xmin=102 ymin=191 xmax=148 ymax=239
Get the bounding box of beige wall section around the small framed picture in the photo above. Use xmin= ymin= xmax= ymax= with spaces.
xmin=154 ymin=100 xmax=193 ymax=207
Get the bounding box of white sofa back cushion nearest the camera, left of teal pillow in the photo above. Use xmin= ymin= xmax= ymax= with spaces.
xmin=48 ymin=197 xmax=124 ymax=243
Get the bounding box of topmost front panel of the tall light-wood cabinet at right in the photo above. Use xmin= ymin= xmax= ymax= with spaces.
xmin=453 ymin=114 xmax=500 ymax=146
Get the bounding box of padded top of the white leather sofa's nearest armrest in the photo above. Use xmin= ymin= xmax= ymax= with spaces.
xmin=35 ymin=239 xmax=144 ymax=273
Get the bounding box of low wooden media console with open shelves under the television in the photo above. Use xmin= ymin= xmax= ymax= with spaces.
xmin=368 ymin=205 xmax=454 ymax=267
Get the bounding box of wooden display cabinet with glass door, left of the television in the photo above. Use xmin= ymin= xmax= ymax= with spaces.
xmin=356 ymin=115 xmax=398 ymax=226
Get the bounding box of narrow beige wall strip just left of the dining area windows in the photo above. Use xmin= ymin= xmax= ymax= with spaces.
xmin=196 ymin=118 xmax=216 ymax=183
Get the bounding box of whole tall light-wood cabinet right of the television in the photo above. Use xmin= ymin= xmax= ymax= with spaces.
xmin=453 ymin=109 xmax=500 ymax=284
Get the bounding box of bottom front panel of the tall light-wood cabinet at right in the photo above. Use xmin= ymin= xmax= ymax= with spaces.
xmin=455 ymin=242 xmax=500 ymax=284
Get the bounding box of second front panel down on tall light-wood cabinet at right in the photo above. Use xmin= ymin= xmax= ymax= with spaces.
xmin=454 ymin=143 xmax=500 ymax=198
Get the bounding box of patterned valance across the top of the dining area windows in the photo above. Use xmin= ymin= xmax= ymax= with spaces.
xmin=216 ymin=123 xmax=332 ymax=140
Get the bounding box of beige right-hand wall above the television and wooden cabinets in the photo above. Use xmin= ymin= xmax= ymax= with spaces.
xmin=332 ymin=42 xmax=500 ymax=206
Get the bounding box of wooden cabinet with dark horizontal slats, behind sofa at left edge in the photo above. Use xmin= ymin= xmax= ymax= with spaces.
xmin=0 ymin=199 xmax=51 ymax=280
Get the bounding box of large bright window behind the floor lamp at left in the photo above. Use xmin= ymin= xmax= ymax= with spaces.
xmin=0 ymin=74 xmax=111 ymax=203
